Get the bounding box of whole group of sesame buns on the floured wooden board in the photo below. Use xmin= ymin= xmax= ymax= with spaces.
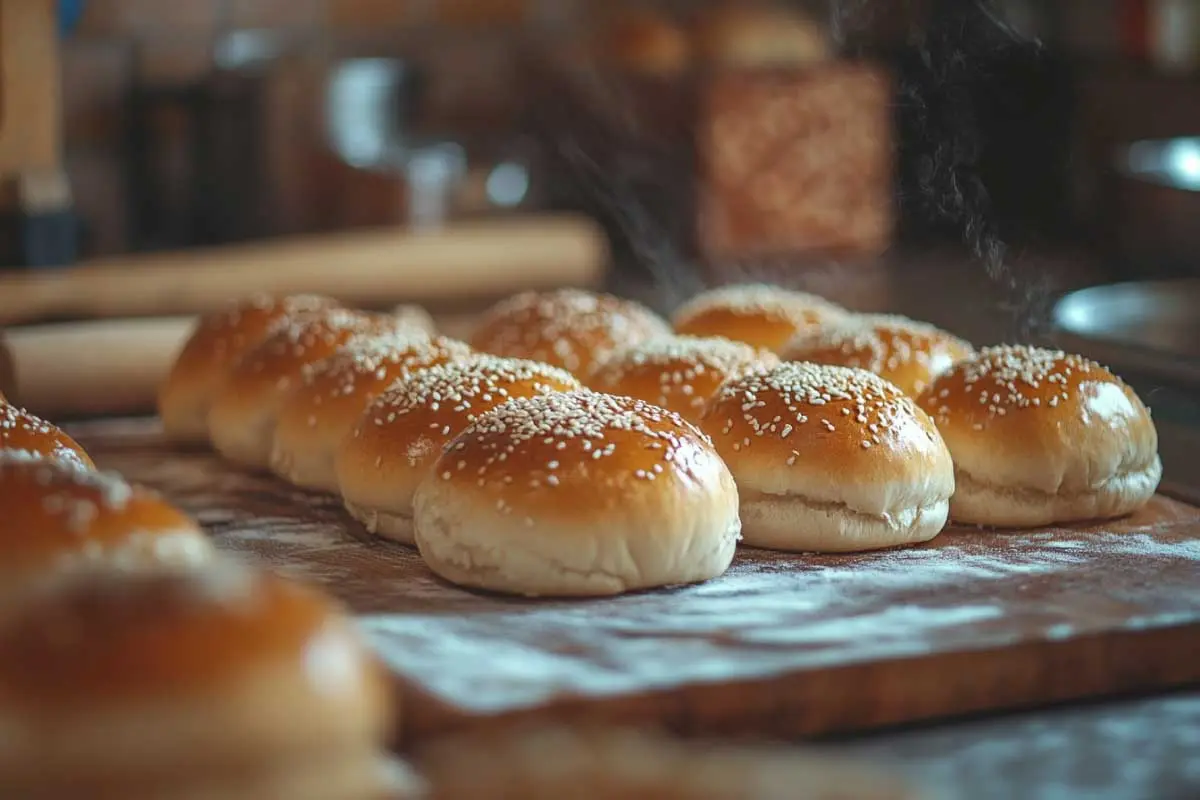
xmin=161 ymin=285 xmax=1162 ymax=595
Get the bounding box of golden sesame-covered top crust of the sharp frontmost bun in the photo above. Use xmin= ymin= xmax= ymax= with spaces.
xmin=428 ymin=390 xmax=728 ymax=525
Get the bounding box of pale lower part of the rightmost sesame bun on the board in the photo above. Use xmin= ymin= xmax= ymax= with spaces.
xmin=950 ymin=456 xmax=1163 ymax=528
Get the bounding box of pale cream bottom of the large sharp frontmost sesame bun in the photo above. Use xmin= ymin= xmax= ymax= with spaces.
xmin=413 ymin=491 xmax=740 ymax=597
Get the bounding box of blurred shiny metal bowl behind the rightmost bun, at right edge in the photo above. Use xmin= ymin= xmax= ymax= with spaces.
xmin=1054 ymin=278 xmax=1200 ymax=387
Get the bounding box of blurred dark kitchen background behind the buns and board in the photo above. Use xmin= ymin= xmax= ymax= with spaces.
xmin=0 ymin=0 xmax=1200 ymax=438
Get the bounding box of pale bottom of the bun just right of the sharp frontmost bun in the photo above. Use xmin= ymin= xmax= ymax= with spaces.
xmin=742 ymin=493 xmax=949 ymax=553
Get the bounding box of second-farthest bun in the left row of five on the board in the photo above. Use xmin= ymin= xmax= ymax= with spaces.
xmin=209 ymin=308 xmax=408 ymax=469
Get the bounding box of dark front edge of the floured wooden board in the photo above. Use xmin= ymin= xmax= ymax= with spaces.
xmin=396 ymin=622 xmax=1200 ymax=750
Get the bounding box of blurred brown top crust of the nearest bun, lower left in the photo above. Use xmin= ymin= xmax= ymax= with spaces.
xmin=0 ymin=561 xmax=367 ymax=715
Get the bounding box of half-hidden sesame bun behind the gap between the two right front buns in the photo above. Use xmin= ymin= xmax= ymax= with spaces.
xmin=780 ymin=314 xmax=974 ymax=397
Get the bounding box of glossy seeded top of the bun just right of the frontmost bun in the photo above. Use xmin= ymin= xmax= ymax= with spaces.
xmin=702 ymin=362 xmax=954 ymax=515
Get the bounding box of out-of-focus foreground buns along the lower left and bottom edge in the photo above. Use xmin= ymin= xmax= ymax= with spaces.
xmin=0 ymin=400 xmax=924 ymax=800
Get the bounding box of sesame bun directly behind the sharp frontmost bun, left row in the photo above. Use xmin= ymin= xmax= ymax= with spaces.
xmin=336 ymin=355 xmax=580 ymax=545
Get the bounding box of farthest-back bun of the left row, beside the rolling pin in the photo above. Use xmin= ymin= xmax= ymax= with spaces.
xmin=158 ymin=295 xmax=337 ymax=444
